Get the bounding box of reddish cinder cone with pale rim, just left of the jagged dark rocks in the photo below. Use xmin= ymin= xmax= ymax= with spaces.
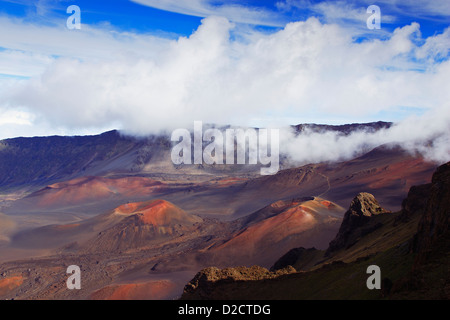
xmin=211 ymin=198 xmax=345 ymax=265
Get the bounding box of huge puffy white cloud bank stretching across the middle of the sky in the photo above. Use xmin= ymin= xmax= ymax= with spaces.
xmin=1 ymin=18 xmax=448 ymax=128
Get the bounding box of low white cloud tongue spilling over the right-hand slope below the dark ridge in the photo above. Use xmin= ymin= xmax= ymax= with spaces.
xmin=280 ymin=104 xmax=450 ymax=165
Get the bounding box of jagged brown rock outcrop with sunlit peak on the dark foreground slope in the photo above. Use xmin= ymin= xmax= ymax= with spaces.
xmin=325 ymin=193 xmax=390 ymax=256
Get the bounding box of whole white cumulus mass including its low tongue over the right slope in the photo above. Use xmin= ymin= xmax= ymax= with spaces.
xmin=0 ymin=17 xmax=450 ymax=161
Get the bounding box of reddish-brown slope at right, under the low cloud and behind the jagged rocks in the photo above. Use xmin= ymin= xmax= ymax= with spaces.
xmin=236 ymin=145 xmax=436 ymax=210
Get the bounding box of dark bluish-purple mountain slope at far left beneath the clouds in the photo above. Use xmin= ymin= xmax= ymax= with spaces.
xmin=0 ymin=131 xmax=144 ymax=188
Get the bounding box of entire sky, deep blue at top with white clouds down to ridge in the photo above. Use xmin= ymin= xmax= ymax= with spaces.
xmin=0 ymin=0 xmax=450 ymax=164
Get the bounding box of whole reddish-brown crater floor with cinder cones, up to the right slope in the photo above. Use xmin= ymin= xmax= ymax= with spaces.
xmin=0 ymin=148 xmax=435 ymax=300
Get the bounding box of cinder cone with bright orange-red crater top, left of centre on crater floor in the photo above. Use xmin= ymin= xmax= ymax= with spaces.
xmin=7 ymin=200 xmax=203 ymax=251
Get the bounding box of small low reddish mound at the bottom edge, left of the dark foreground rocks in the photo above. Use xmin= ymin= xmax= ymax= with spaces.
xmin=90 ymin=280 xmax=177 ymax=300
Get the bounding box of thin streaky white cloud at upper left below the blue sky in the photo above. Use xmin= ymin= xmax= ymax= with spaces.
xmin=0 ymin=16 xmax=171 ymax=76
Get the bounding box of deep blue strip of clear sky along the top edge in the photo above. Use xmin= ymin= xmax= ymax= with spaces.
xmin=0 ymin=0 xmax=450 ymax=37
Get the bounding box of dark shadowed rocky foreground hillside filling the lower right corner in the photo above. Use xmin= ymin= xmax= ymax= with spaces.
xmin=182 ymin=163 xmax=450 ymax=300
